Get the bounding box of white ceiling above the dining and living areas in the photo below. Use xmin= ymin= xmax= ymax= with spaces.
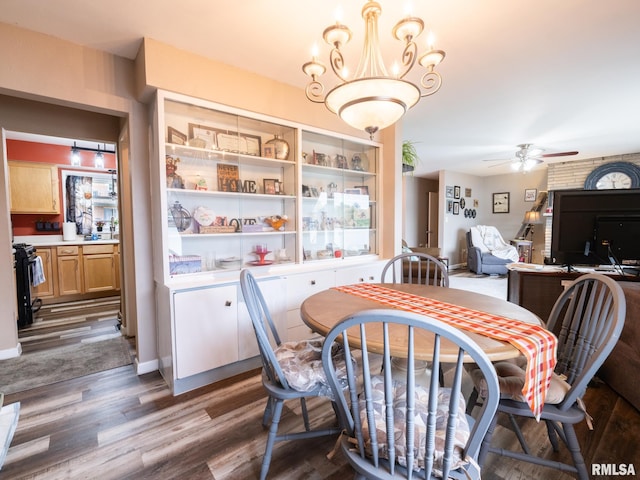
xmin=0 ymin=0 xmax=640 ymax=178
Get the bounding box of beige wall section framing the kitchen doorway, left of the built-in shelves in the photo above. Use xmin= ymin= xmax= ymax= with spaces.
xmin=0 ymin=24 xmax=156 ymax=362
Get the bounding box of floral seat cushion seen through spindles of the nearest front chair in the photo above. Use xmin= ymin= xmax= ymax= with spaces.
xmin=360 ymin=376 xmax=469 ymax=470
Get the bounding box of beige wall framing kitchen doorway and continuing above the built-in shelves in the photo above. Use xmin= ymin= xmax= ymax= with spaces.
xmin=0 ymin=24 xmax=402 ymax=366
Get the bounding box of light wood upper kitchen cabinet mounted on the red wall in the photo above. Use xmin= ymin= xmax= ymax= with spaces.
xmin=8 ymin=161 xmax=60 ymax=214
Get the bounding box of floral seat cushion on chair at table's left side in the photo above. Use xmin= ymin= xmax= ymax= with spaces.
xmin=275 ymin=340 xmax=346 ymax=396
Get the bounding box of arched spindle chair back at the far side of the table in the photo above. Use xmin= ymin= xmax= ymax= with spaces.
xmin=381 ymin=252 xmax=449 ymax=287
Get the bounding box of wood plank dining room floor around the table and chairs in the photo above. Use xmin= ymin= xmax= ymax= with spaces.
xmin=0 ymin=332 xmax=640 ymax=480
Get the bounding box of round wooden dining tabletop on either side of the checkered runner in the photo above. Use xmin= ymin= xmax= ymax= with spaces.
xmin=300 ymin=283 xmax=542 ymax=362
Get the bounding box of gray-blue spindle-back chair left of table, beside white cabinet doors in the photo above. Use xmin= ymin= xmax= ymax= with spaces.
xmin=240 ymin=269 xmax=340 ymax=480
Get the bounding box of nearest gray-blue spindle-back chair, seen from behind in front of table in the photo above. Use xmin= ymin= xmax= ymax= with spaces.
xmin=322 ymin=309 xmax=500 ymax=479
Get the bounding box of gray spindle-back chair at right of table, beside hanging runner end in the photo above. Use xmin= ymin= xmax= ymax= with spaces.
xmin=480 ymin=274 xmax=626 ymax=480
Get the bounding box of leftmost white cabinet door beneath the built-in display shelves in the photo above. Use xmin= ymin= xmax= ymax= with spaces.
xmin=173 ymin=285 xmax=238 ymax=379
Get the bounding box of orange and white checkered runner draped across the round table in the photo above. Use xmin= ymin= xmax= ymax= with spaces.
xmin=335 ymin=283 xmax=557 ymax=420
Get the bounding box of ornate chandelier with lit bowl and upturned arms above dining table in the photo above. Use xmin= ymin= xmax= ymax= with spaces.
xmin=302 ymin=1 xmax=445 ymax=137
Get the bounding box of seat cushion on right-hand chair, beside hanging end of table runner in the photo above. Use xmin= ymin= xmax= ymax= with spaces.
xmin=469 ymin=357 xmax=571 ymax=405
